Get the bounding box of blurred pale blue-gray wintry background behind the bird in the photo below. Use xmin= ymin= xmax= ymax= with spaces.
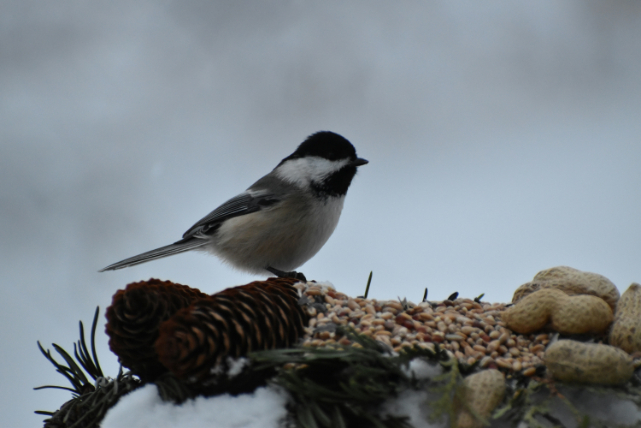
xmin=0 ymin=0 xmax=641 ymax=427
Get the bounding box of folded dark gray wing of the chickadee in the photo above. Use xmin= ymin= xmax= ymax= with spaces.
xmin=183 ymin=190 xmax=280 ymax=239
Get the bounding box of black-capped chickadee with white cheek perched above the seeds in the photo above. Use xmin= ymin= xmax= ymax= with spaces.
xmin=100 ymin=131 xmax=368 ymax=280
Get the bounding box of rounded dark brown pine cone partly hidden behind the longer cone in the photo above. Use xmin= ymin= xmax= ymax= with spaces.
xmin=106 ymin=278 xmax=207 ymax=381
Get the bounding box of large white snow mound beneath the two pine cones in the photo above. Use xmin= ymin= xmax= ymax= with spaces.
xmin=101 ymin=384 xmax=287 ymax=428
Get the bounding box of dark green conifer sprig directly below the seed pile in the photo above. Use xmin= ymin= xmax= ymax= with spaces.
xmin=251 ymin=328 xmax=449 ymax=428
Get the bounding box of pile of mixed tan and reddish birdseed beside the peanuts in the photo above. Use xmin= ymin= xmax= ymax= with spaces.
xmin=295 ymin=282 xmax=550 ymax=376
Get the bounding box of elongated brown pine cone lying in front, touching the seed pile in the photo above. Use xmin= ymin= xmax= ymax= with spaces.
xmin=156 ymin=278 xmax=308 ymax=381
